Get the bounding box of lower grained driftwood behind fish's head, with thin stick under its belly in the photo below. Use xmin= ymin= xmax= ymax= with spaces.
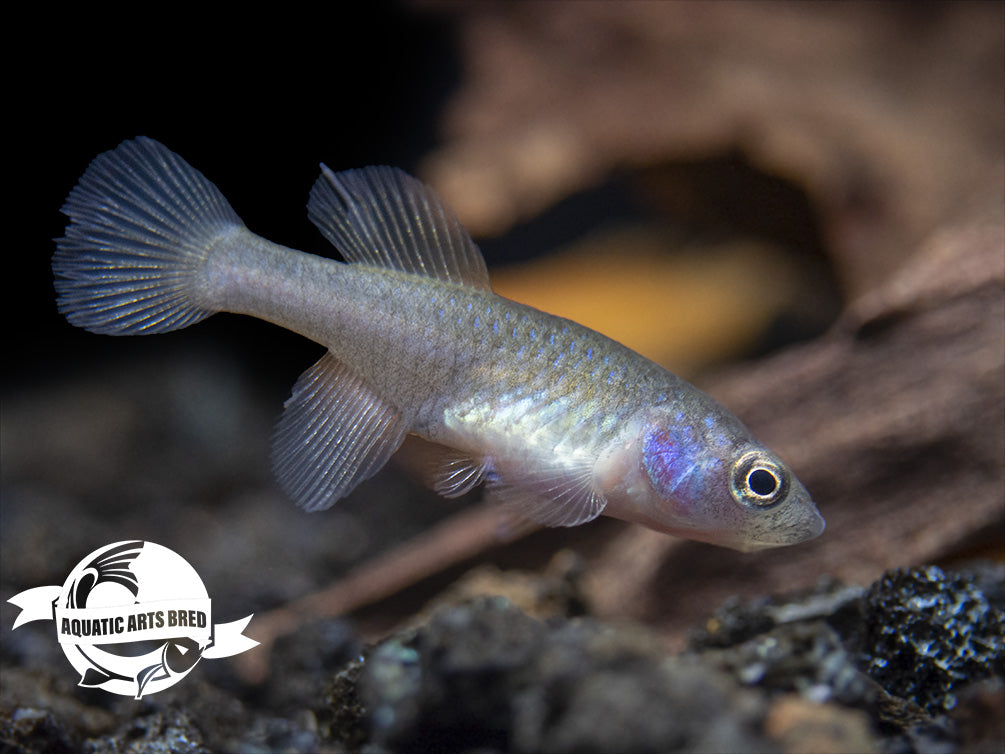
xmin=242 ymin=205 xmax=1005 ymax=680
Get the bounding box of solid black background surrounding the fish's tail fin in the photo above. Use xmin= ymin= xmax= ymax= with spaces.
xmin=3 ymin=2 xmax=458 ymax=392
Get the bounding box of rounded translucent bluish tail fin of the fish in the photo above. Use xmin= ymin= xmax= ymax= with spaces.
xmin=52 ymin=137 xmax=243 ymax=335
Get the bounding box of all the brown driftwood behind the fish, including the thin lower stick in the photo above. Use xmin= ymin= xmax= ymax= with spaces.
xmin=237 ymin=3 xmax=1005 ymax=677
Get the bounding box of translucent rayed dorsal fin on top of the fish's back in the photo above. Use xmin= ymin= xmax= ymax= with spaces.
xmin=308 ymin=164 xmax=489 ymax=291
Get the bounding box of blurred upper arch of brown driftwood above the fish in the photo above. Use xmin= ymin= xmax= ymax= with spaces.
xmin=425 ymin=2 xmax=1005 ymax=300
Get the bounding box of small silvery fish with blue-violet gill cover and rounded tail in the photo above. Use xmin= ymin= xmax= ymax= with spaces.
xmin=52 ymin=138 xmax=824 ymax=550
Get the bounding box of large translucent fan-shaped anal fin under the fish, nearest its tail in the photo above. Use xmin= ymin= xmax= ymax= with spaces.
xmin=272 ymin=353 xmax=406 ymax=511
